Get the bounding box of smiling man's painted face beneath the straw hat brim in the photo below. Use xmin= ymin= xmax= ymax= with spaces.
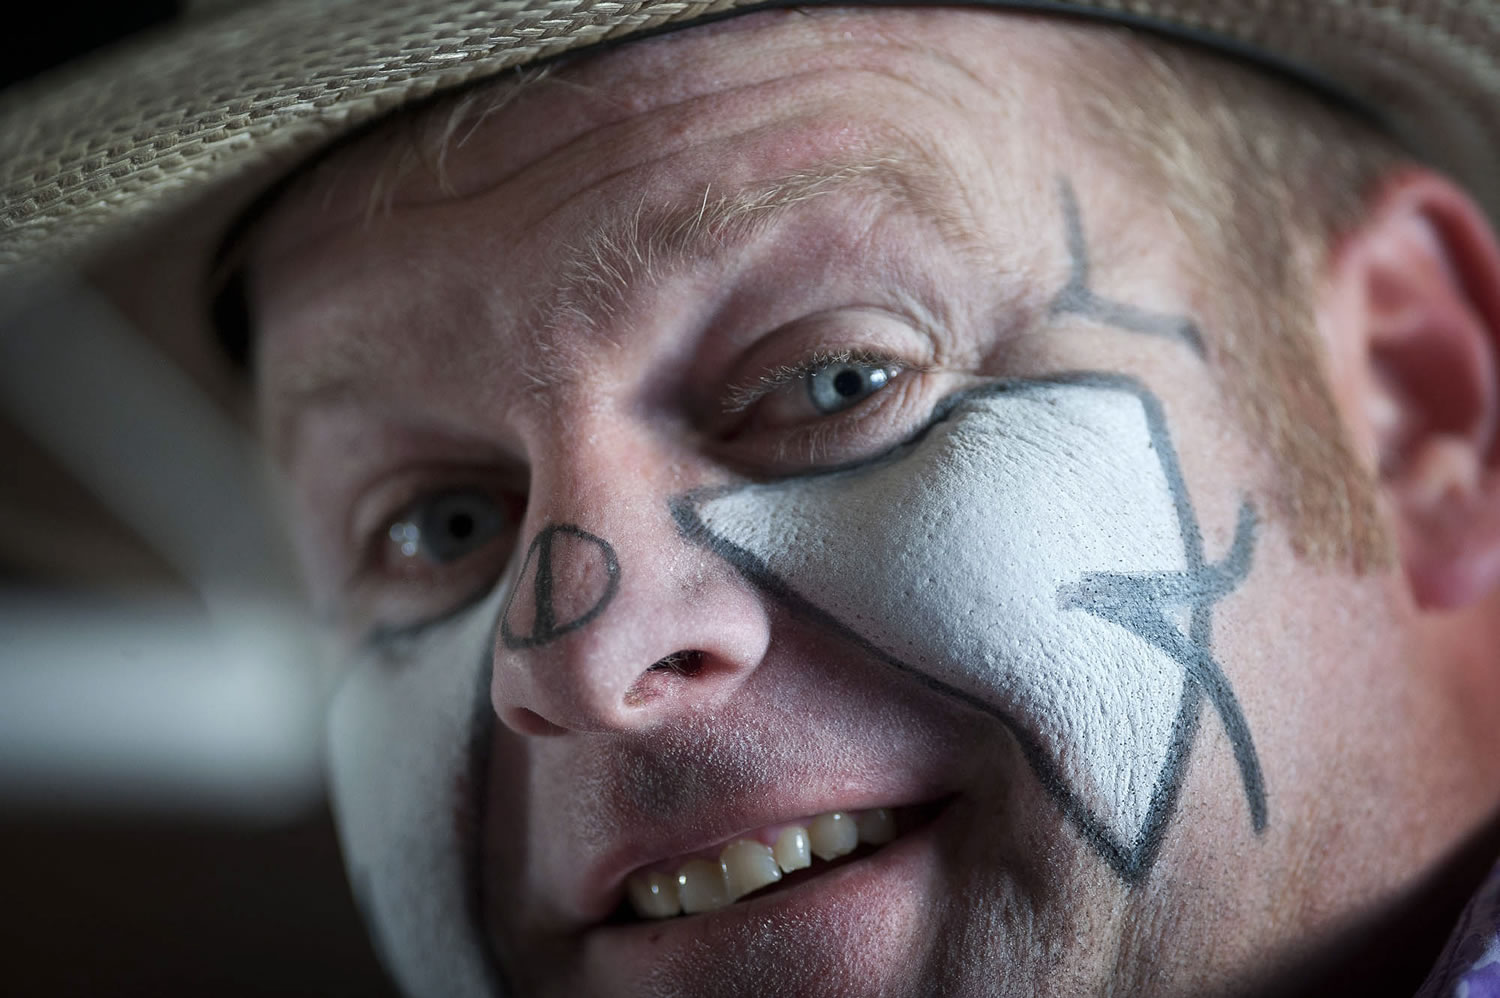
xmin=252 ymin=12 xmax=1500 ymax=995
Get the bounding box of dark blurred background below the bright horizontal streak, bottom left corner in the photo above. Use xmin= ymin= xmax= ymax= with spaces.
xmin=0 ymin=809 xmax=395 ymax=998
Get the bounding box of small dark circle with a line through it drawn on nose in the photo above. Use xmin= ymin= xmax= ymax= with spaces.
xmin=500 ymin=524 xmax=620 ymax=650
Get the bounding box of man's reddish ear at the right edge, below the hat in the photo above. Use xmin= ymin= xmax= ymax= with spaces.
xmin=1320 ymin=170 xmax=1500 ymax=609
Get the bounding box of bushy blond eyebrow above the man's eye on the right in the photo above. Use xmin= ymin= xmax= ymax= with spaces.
xmin=524 ymin=143 xmax=987 ymax=389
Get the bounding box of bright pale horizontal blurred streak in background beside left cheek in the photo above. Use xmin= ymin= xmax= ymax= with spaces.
xmin=0 ymin=594 xmax=323 ymax=821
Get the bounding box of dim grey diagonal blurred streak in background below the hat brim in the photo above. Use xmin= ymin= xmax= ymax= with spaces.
xmin=0 ymin=276 xmax=297 ymax=611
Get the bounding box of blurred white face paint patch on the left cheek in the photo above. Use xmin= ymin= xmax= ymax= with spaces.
xmin=329 ymin=591 xmax=503 ymax=998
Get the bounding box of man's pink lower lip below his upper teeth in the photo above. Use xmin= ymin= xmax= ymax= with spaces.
xmin=584 ymin=804 xmax=956 ymax=990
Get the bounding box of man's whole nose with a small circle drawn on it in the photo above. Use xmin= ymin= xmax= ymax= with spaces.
xmin=491 ymin=447 xmax=770 ymax=735
